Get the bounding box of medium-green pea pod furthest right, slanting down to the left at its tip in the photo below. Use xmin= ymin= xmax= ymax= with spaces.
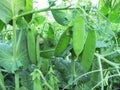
xmin=81 ymin=30 xmax=96 ymax=72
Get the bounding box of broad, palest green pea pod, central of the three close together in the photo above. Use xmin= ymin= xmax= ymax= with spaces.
xmin=73 ymin=13 xmax=85 ymax=57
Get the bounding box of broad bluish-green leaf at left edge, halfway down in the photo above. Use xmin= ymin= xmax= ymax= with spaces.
xmin=0 ymin=43 xmax=22 ymax=73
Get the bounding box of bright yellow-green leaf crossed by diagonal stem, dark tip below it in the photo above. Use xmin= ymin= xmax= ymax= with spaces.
xmin=24 ymin=0 xmax=33 ymax=22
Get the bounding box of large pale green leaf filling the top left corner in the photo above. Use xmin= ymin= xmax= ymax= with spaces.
xmin=0 ymin=0 xmax=25 ymax=24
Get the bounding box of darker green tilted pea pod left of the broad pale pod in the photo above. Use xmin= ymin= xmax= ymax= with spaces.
xmin=55 ymin=27 xmax=71 ymax=56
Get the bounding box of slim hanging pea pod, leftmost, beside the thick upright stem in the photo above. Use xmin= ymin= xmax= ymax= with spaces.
xmin=27 ymin=29 xmax=36 ymax=64
